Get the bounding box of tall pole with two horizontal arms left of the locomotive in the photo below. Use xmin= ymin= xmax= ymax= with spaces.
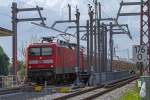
xmin=12 ymin=2 xmax=46 ymax=79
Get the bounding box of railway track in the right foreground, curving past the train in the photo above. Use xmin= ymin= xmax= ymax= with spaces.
xmin=53 ymin=75 xmax=138 ymax=100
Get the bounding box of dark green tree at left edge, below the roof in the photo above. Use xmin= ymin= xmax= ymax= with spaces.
xmin=0 ymin=46 xmax=9 ymax=75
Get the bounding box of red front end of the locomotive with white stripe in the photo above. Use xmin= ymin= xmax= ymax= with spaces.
xmin=26 ymin=44 xmax=55 ymax=82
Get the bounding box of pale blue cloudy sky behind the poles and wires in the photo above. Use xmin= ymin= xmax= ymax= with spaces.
xmin=0 ymin=0 xmax=140 ymax=59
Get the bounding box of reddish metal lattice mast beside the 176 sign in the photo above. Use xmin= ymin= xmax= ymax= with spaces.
xmin=140 ymin=0 xmax=150 ymax=72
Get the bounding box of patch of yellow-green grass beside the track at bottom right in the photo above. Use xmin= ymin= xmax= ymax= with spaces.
xmin=120 ymin=82 xmax=141 ymax=100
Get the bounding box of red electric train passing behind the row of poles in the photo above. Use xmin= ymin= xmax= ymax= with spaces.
xmin=26 ymin=38 xmax=135 ymax=84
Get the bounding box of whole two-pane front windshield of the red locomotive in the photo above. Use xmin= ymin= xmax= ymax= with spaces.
xmin=29 ymin=47 xmax=52 ymax=56
